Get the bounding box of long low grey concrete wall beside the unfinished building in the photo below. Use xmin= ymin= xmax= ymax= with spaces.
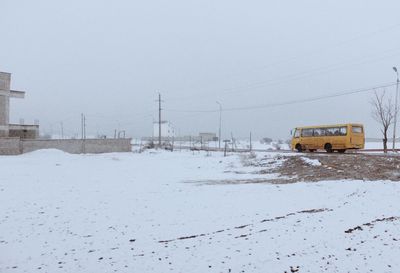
xmin=21 ymin=138 xmax=132 ymax=154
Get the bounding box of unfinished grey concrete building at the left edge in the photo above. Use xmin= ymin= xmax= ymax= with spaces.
xmin=0 ymin=72 xmax=39 ymax=139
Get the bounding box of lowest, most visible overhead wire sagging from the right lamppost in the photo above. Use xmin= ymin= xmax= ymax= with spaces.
xmin=165 ymin=82 xmax=396 ymax=113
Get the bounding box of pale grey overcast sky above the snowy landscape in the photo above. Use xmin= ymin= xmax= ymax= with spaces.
xmin=0 ymin=0 xmax=400 ymax=138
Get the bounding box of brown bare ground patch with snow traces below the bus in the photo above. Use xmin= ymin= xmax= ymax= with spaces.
xmin=194 ymin=153 xmax=400 ymax=185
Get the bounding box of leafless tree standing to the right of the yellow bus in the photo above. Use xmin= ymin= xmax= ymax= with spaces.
xmin=371 ymin=90 xmax=395 ymax=153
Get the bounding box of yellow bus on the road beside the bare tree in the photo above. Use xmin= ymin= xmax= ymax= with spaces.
xmin=291 ymin=124 xmax=365 ymax=153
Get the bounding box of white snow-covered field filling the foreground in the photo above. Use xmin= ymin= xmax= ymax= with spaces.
xmin=0 ymin=150 xmax=400 ymax=273
